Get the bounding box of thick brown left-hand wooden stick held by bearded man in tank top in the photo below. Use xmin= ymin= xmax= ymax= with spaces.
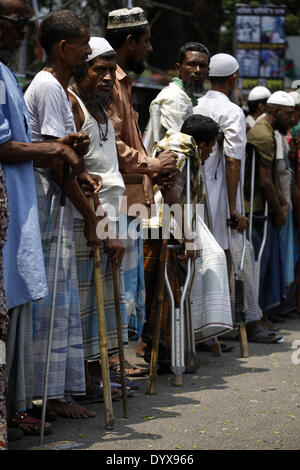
xmin=88 ymin=196 xmax=114 ymax=429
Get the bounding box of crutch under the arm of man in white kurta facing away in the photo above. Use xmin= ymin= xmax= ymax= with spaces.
xmin=223 ymin=153 xmax=249 ymax=357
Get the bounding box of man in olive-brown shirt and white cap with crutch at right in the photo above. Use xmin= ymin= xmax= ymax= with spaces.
xmin=244 ymin=91 xmax=295 ymax=334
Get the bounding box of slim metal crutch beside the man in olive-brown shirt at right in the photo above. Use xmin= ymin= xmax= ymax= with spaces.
xmin=247 ymin=148 xmax=268 ymax=300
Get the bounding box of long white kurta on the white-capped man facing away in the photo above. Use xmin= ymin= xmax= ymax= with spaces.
xmin=193 ymin=90 xmax=246 ymax=250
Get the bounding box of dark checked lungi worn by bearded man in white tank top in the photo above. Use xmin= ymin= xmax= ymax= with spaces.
xmin=74 ymin=219 xmax=128 ymax=359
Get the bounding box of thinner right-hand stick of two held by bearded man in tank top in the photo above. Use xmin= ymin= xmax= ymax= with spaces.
xmin=112 ymin=260 xmax=128 ymax=418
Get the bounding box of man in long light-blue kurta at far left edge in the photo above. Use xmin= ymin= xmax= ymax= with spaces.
xmin=0 ymin=0 xmax=84 ymax=437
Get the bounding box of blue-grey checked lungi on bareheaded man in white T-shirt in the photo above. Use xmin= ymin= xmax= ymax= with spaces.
xmin=33 ymin=171 xmax=85 ymax=398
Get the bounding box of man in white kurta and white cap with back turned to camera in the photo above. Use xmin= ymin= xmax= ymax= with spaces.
xmin=193 ymin=53 xmax=248 ymax=266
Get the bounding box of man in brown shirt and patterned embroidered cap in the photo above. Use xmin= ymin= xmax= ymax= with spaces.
xmin=106 ymin=8 xmax=176 ymax=375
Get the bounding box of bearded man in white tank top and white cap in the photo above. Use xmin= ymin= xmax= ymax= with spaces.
xmin=69 ymin=37 xmax=137 ymax=395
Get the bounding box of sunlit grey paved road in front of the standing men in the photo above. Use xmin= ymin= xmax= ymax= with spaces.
xmin=9 ymin=317 xmax=300 ymax=451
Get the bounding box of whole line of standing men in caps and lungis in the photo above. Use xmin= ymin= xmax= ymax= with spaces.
xmin=0 ymin=0 xmax=300 ymax=449
